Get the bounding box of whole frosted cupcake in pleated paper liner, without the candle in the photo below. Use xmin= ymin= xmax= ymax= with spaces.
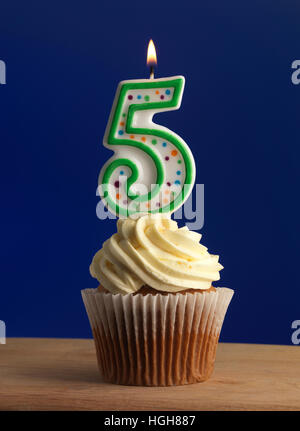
xmin=82 ymin=214 xmax=233 ymax=386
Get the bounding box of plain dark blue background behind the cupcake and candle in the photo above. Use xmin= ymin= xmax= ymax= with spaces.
xmin=0 ymin=0 xmax=300 ymax=344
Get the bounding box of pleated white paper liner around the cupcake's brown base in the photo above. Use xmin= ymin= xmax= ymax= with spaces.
xmin=81 ymin=288 xmax=233 ymax=386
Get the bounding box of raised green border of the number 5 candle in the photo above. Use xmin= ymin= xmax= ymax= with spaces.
xmin=102 ymin=77 xmax=195 ymax=216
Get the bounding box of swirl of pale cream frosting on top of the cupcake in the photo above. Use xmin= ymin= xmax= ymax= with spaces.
xmin=90 ymin=214 xmax=223 ymax=295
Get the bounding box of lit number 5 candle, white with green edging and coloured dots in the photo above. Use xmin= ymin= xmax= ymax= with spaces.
xmin=99 ymin=41 xmax=195 ymax=217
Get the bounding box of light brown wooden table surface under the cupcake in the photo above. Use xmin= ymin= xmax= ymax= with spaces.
xmin=0 ymin=338 xmax=300 ymax=410
